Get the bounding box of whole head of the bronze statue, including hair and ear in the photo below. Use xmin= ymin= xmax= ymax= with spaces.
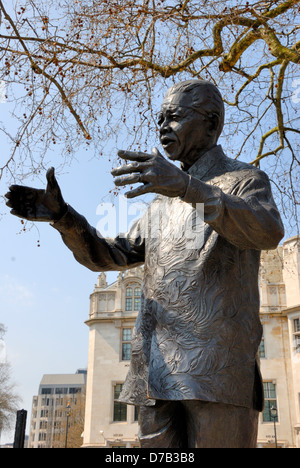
xmin=158 ymin=80 xmax=225 ymax=165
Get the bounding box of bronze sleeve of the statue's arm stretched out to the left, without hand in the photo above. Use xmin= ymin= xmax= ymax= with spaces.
xmin=51 ymin=205 xmax=145 ymax=272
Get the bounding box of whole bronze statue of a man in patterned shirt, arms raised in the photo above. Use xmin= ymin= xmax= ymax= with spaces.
xmin=7 ymin=80 xmax=284 ymax=448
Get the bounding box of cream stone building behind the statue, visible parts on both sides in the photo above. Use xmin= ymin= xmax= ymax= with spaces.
xmin=83 ymin=237 xmax=300 ymax=448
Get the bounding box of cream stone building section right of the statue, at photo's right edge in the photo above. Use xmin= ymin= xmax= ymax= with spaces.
xmin=258 ymin=237 xmax=300 ymax=448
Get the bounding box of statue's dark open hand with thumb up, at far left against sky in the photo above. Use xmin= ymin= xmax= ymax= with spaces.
xmin=5 ymin=167 xmax=67 ymax=222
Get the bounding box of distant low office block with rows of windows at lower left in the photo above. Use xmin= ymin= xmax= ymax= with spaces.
xmin=28 ymin=369 xmax=87 ymax=448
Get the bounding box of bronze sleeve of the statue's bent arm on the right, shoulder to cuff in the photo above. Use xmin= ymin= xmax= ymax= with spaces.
xmin=183 ymin=170 xmax=284 ymax=250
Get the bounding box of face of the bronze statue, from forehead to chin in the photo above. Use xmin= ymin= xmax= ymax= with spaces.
xmin=158 ymin=93 xmax=212 ymax=165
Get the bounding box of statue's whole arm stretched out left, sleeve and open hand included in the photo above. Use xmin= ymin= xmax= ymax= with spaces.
xmin=6 ymin=167 xmax=144 ymax=271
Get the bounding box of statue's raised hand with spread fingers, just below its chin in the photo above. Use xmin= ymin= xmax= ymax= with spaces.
xmin=111 ymin=148 xmax=189 ymax=198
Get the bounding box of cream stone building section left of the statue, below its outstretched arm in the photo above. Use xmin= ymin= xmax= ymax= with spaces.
xmin=83 ymin=268 xmax=143 ymax=448
